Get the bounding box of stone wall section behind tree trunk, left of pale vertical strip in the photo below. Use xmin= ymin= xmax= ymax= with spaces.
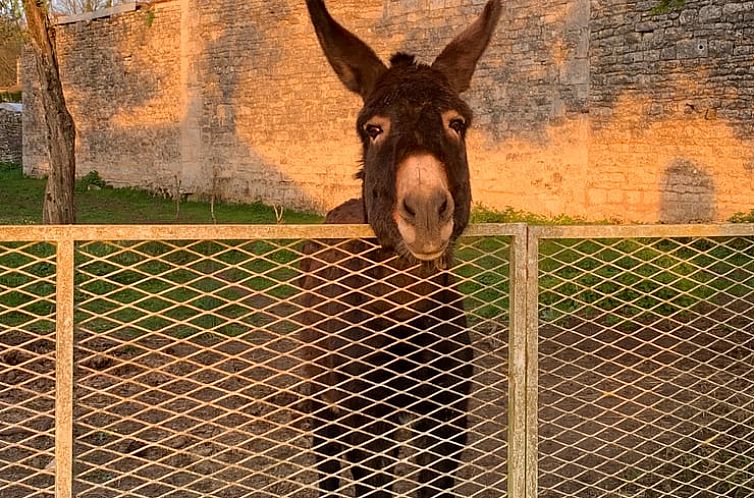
xmin=22 ymin=2 xmax=185 ymax=189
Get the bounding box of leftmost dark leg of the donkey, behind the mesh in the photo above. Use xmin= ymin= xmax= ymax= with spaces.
xmin=312 ymin=410 xmax=346 ymax=498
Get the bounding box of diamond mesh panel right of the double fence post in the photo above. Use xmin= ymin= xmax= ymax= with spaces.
xmin=538 ymin=237 xmax=754 ymax=498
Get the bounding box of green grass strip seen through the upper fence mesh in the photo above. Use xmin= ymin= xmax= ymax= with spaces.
xmin=0 ymin=231 xmax=754 ymax=337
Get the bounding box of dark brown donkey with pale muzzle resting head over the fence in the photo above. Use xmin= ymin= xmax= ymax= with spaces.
xmin=300 ymin=0 xmax=502 ymax=498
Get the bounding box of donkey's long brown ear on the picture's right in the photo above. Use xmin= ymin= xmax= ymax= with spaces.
xmin=432 ymin=0 xmax=503 ymax=93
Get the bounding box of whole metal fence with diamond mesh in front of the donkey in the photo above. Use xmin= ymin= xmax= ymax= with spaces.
xmin=0 ymin=225 xmax=754 ymax=498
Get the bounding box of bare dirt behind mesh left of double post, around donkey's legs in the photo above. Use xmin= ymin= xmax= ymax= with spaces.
xmin=0 ymin=320 xmax=507 ymax=498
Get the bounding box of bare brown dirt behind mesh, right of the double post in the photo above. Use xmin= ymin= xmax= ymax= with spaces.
xmin=539 ymin=303 xmax=754 ymax=498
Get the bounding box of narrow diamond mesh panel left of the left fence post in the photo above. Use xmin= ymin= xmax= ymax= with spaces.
xmin=0 ymin=242 xmax=55 ymax=498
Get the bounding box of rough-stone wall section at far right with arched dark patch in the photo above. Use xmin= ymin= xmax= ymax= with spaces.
xmin=586 ymin=0 xmax=754 ymax=222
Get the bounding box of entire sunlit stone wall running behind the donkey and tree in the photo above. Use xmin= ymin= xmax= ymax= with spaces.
xmin=24 ymin=0 xmax=754 ymax=221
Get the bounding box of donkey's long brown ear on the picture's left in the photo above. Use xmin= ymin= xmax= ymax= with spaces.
xmin=306 ymin=0 xmax=387 ymax=98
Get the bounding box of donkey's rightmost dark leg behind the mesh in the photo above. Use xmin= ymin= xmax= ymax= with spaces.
xmin=416 ymin=408 xmax=466 ymax=498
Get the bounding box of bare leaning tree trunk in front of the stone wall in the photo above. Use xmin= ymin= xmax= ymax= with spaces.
xmin=23 ymin=0 xmax=76 ymax=224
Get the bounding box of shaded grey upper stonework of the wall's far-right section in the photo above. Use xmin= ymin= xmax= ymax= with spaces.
xmin=589 ymin=1 xmax=754 ymax=144
